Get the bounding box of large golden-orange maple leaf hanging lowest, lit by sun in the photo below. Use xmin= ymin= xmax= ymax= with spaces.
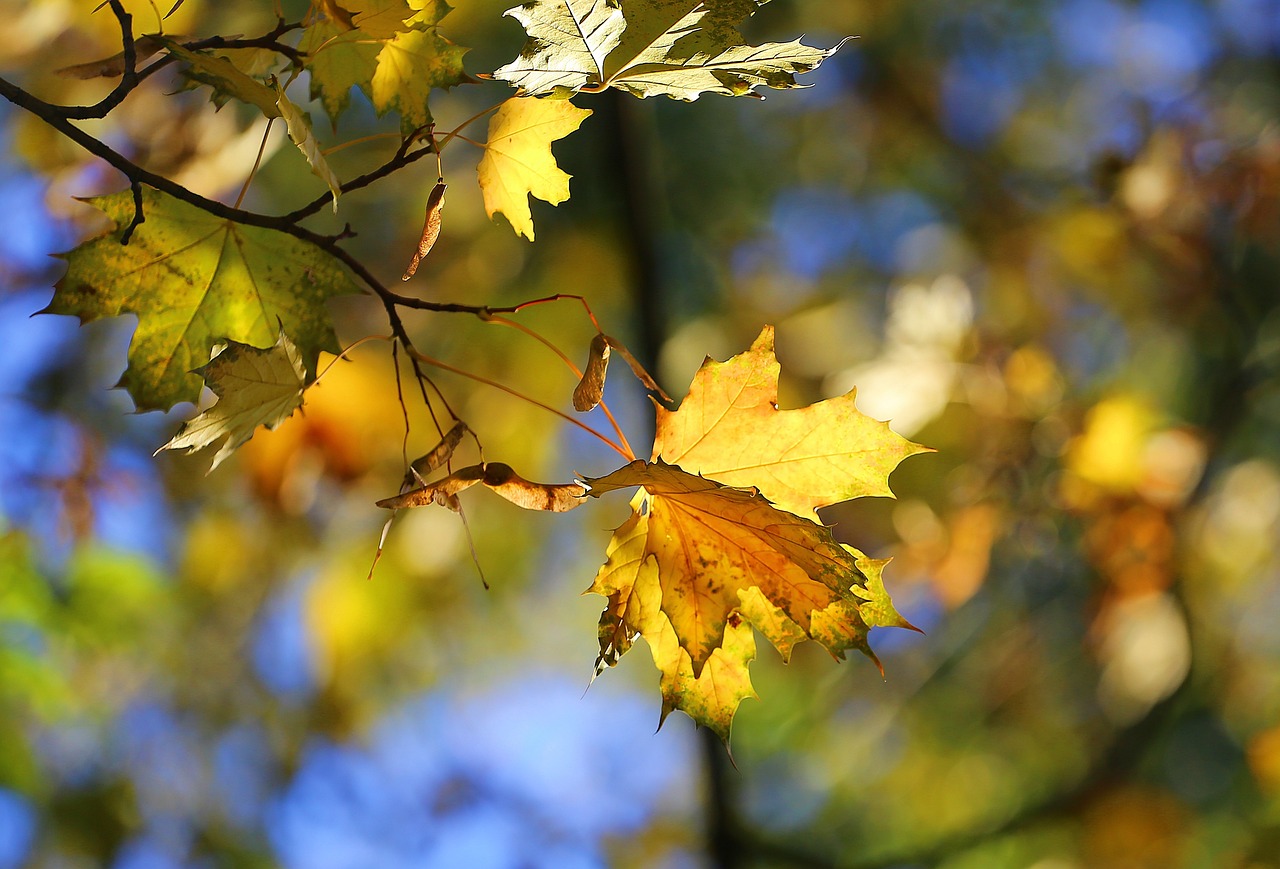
xmin=588 ymin=326 xmax=928 ymax=740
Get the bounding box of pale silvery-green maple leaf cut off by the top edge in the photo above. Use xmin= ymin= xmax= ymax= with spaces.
xmin=493 ymin=0 xmax=844 ymax=100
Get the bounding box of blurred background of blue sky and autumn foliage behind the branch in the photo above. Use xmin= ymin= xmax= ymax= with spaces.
xmin=0 ymin=0 xmax=1280 ymax=869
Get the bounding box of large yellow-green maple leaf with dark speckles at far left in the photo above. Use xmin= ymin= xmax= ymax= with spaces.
xmin=45 ymin=188 xmax=358 ymax=411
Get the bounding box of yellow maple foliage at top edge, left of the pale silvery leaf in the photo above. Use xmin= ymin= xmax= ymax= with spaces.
xmin=298 ymin=0 xmax=468 ymax=131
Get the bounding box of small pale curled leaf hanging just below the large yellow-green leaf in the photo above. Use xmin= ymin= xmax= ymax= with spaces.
xmin=156 ymin=331 xmax=307 ymax=471
